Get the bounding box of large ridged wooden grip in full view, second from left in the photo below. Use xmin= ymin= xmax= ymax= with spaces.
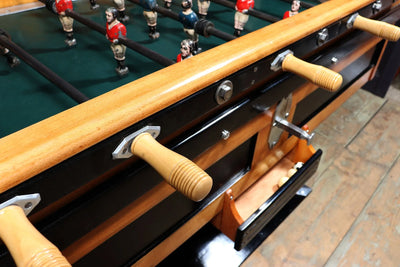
xmin=131 ymin=133 xmax=213 ymax=201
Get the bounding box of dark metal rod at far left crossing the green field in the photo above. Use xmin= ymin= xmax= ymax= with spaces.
xmin=0 ymin=33 xmax=89 ymax=103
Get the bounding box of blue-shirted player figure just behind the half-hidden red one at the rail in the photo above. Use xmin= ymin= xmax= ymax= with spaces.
xmin=179 ymin=0 xmax=201 ymax=54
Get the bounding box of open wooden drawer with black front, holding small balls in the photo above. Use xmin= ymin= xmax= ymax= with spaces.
xmin=213 ymin=140 xmax=322 ymax=250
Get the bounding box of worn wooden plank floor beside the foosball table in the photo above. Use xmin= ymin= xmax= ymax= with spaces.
xmin=242 ymin=77 xmax=400 ymax=267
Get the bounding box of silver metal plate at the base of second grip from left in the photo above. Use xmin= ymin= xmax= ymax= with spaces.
xmin=112 ymin=126 xmax=161 ymax=159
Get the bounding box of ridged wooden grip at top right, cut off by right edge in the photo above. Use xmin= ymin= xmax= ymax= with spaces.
xmin=353 ymin=15 xmax=400 ymax=42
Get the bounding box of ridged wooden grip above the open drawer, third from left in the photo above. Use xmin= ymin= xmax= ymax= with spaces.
xmin=282 ymin=54 xmax=343 ymax=92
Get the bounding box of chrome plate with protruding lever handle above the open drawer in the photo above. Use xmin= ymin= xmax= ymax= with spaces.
xmin=268 ymin=94 xmax=314 ymax=148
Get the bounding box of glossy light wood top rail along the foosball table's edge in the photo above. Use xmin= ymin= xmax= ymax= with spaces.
xmin=0 ymin=0 xmax=373 ymax=195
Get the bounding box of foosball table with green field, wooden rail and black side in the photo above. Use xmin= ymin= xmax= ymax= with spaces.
xmin=0 ymin=0 xmax=400 ymax=266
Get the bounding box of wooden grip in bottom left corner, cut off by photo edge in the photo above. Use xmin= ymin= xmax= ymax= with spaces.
xmin=0 ymin=205 xmax=71 ymax=267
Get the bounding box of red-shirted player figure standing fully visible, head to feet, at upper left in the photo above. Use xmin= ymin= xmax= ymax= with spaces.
xmin=105 ymin=7 xmax=129 ymax=76
